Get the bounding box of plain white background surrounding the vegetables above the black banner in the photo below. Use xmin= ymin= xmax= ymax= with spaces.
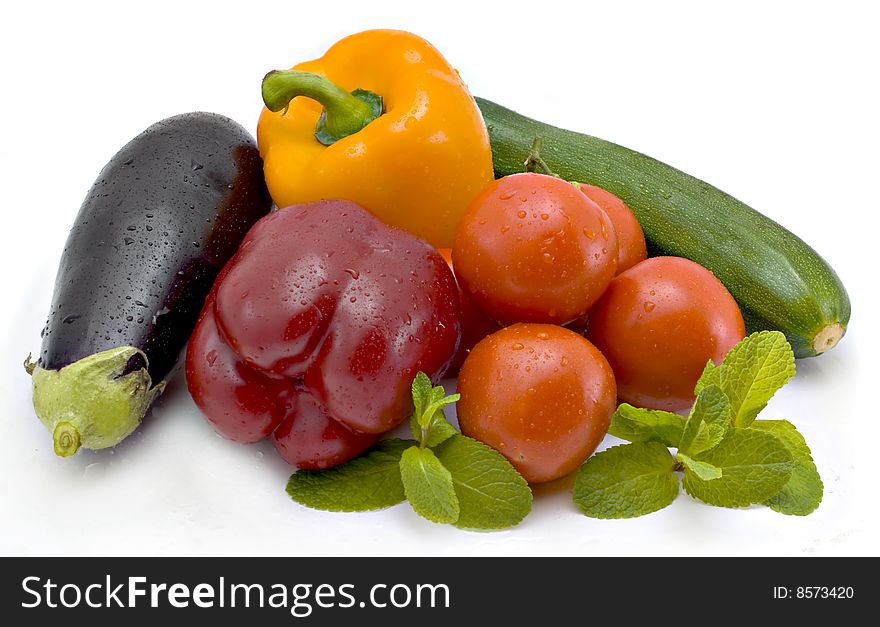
xmin=0 ymin=0 xmax=880 ymax=555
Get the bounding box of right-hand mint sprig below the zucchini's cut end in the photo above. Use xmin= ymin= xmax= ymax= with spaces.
xmin=574 ymin=331 xmax=823 ymax=518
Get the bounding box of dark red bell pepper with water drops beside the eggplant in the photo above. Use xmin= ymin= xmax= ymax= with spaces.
xmin=186 ymin=200 xmax=461 ymax=468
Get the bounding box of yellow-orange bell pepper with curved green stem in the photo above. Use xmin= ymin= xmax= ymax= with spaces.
xmin=257 ymin=30 xmax=493 ymax=247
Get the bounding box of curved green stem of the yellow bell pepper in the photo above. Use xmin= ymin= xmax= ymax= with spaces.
xmin=262 ymin=70 xmax=382 ymax=146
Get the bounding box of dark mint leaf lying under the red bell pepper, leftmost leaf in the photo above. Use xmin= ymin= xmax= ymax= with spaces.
xmin=287 ymin=439 xmax=413 ymax=512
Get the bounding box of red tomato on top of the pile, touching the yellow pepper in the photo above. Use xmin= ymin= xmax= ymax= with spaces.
xmin=452 ymin=173 xmax=617 ymax=324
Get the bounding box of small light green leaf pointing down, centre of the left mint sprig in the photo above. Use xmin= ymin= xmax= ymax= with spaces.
xmin=400 ymin=446 xmax=459 ymax=523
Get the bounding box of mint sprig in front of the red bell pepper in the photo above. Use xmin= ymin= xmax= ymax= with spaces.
xmin=287 ymin=372 xmax=532 ymax=530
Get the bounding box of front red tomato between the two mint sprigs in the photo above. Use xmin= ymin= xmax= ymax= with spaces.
xmin=457 ymin=324 xmax=617 ymax=483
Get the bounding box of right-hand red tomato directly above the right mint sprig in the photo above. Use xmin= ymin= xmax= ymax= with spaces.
xmin=587 ymin=257 xmax=745 ymax=411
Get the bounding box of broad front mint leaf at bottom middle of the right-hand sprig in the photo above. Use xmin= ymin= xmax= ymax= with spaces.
xmin=683 ymin=429 xmax=794 ymax=507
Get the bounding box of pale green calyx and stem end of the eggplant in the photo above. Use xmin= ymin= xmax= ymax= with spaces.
xmin=31 ymin=346 xmax=165 ymax=457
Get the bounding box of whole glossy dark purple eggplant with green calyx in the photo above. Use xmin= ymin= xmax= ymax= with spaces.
xmin=25 ymin=112 xmax=272 ymax=457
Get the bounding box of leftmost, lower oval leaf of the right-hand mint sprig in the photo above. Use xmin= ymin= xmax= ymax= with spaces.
xmin=574 ymin=442 xmax=678 ymax=518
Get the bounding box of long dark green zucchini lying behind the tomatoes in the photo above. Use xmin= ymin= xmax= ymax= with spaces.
xmin=476 ymin=98 xmax=850 ymax=357
